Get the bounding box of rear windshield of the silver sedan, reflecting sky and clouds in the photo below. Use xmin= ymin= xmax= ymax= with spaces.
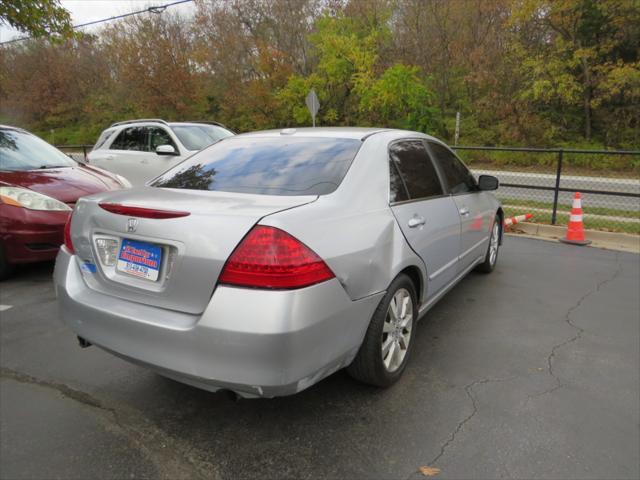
xmin=151 ymin=137 xmax=361 ymax=195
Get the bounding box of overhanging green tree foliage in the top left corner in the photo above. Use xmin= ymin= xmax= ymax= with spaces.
xmin=0 ymin=0 xmax=73 ymax=38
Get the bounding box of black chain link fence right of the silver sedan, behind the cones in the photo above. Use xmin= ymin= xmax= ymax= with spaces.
xmin=454 ymin=146 xmax=640 ymax=234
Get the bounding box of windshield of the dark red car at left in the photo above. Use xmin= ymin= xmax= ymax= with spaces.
xmin=0 ymin=130 xmax=76 ymax=171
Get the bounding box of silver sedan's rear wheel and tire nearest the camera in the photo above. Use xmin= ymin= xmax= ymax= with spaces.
xmin=347 ymin=274 xmax=418 ymax=387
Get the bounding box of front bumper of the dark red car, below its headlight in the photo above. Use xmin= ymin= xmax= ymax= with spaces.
xmin=0 ymin=204 xmax=70 ymax=263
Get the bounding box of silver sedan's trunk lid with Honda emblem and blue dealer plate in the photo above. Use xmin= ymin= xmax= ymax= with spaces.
xmin=71 ymin=187 xmax=317 ymax=314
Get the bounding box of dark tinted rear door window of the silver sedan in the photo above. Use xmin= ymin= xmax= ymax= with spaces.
xmin=389 ymin=140 xmax=443 ymax=201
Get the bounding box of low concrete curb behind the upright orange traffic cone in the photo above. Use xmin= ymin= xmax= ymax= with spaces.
xmin=505 ymin=222 xmax=640 ymax=254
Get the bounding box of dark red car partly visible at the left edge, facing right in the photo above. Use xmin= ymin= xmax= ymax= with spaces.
xmin=0 ymin=125 xmax=130 ymax=279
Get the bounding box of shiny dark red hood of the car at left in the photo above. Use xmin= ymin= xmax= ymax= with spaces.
xmin=0 ymin=164 xmax=122 ymax=203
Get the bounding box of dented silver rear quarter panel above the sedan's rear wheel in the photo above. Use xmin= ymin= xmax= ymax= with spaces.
xmin=260 ymin=132 xmax=426 ymax=300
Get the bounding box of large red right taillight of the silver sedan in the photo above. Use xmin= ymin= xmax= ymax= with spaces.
xmin=219 ymin=225 xmax=335 ymax=289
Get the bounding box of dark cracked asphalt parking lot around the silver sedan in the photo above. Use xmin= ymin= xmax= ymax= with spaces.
xmin=0 ymin=237 xmax=640 ymax=479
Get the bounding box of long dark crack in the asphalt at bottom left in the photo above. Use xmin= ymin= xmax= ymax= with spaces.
xmin=0 ymin=367 xmax=220 ymax=480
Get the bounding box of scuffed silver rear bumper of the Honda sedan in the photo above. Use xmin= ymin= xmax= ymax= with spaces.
xmin=54 ymin=248 xmax=384 ymax=397
